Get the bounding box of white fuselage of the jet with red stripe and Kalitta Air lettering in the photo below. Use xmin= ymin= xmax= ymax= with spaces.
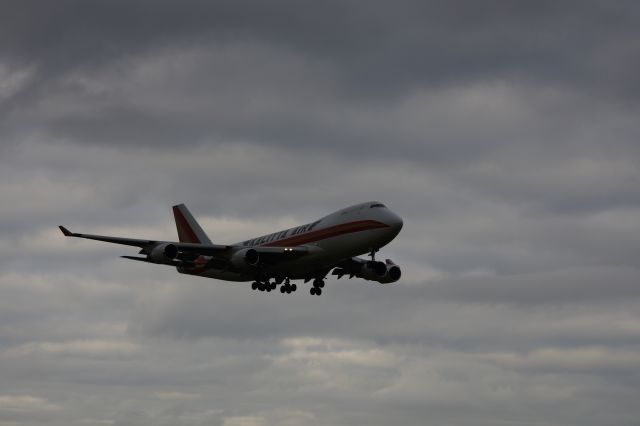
xmin=177 ymin=201 xmax=402 ymax=281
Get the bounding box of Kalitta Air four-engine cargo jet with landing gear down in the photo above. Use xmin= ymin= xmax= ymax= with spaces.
xmin=59 ymin=201 xmax=403 ymax=296
